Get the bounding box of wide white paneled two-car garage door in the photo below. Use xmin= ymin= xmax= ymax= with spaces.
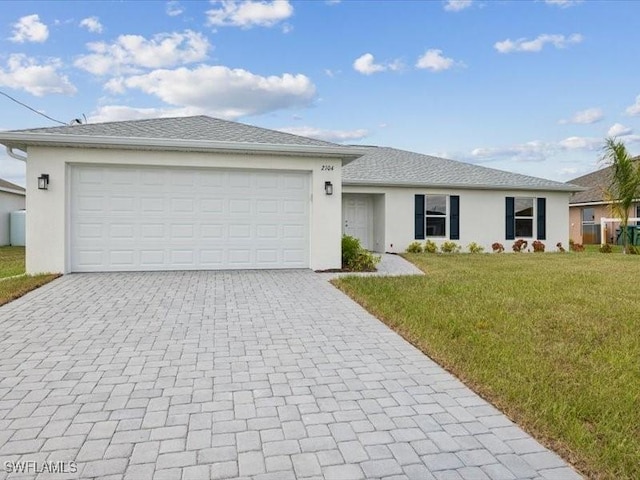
xmin=70 ymin=165 xmax=309 ymax=272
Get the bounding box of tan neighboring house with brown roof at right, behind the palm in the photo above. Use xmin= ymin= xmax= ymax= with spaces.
xmin=569 ymin=161 xmax=640 ymax=245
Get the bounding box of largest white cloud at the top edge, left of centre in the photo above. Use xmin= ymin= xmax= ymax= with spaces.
xmin=207 ymin=0 xmax=293 ymax=28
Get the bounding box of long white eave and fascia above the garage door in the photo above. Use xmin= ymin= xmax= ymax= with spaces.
xmin=0 ymin=132 xmax=366 ymax=165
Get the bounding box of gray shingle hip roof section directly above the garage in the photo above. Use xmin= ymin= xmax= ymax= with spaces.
xmin=10 ymin=115 xmax=336 ymax=147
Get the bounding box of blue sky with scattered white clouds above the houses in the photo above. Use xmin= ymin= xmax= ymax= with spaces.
xmin=0 ymin=0 xmax=640 ymax=185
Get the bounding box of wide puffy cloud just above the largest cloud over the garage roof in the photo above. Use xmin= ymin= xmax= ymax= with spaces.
xmin=74 ymin=30 xmax=211 ymax=75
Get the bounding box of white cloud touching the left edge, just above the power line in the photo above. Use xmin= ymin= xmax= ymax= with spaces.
xmin=0 ymin=53 xmax=77 ymax=97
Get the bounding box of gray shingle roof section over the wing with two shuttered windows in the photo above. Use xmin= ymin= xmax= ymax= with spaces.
xmin=342 ymin=147 xmax=579 ymax=191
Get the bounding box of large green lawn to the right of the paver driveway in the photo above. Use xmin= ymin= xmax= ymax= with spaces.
xmin=335 ymin=253 xmax=640 ymax=479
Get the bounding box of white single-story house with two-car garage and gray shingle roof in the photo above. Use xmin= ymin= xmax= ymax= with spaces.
xmin=0 ymin=116 xmax=576 ymax=273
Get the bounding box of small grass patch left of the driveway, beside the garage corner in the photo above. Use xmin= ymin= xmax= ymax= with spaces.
xmin=0 ymin=247 xmax=59 ymax=305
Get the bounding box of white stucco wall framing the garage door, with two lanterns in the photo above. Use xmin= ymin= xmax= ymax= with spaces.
xmin=26 ymin=147 xmax=342 ymax=273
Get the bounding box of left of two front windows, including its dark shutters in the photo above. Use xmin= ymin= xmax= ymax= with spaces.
xmin=414 ymin=195 xmax=460 ymax=240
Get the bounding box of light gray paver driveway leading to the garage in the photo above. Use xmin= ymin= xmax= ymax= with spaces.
xmin=0 ymin=271 xmax=579 ymax=480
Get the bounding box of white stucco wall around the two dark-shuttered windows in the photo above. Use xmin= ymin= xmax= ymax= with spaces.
xmin=343 ymin=185 xmax=569 ymax=253
